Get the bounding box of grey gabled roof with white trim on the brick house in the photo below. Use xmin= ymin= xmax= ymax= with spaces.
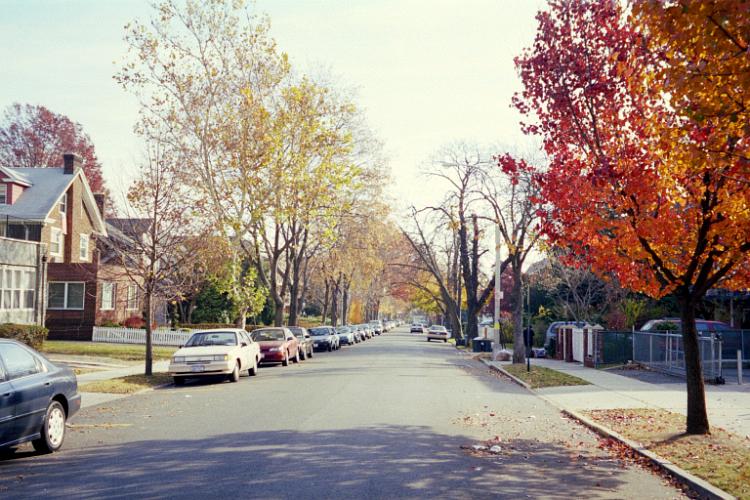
xmin=0 ymin=167 xmax=107 ymax=235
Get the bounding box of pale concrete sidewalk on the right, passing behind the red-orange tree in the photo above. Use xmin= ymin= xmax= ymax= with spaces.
xmin=489 ymin=359 xmax=750 ymax=437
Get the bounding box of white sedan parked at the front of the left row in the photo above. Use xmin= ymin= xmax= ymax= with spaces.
xmin=169 ymin=328 xmax=260 ymax=385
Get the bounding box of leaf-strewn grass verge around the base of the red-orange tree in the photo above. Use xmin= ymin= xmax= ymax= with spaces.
xmin=584 ymin=408 xmax=750 ymax=499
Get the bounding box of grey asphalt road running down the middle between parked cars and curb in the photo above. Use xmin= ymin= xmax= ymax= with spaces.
xmin=0 ymin=332 xmax=680 ymax=499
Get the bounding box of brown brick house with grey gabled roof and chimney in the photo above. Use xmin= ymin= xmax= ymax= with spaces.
xmin=0 ymin=154 xmax=140 ymax=340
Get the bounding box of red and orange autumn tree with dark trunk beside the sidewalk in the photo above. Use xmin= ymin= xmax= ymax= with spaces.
xmin=514 ymin=0 xmax=750 ymax=434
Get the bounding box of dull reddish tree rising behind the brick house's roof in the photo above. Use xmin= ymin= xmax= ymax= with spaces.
xmin=0 ymin=103 xmax=105 ymax=193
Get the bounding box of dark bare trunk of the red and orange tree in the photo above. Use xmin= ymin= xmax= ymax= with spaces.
xmin=681 ymin=292 xmax=710 ymax=434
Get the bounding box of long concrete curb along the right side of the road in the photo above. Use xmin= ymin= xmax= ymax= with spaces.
xmin=481 ymin=359 xmax=736 ymax=500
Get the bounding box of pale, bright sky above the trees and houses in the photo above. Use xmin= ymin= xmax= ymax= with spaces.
xmin=0 ymin=0 xmax=544 ymax=213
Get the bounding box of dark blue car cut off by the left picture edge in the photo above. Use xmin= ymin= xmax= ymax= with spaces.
xmin=0 ymin=339 xmax=81 ymax=453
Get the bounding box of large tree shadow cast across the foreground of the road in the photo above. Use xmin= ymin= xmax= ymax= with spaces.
xmin=0 ymin=418 xmax=640 ymax=499
